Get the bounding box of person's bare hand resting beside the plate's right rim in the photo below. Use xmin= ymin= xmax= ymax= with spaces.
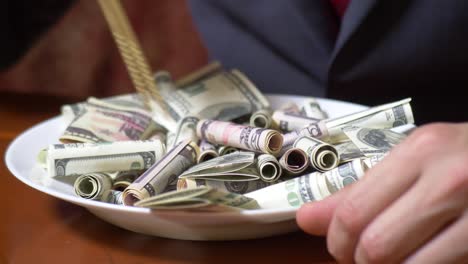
xmin=297 ymin=123 xmax=468 ymax=263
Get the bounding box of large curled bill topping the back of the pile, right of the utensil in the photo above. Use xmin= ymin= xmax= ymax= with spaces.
xmin=153 ymin=69 xmax=270 ymax=132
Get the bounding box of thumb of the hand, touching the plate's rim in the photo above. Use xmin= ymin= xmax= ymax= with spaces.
xmin=296 ymin=184 xmax=354 ymax=236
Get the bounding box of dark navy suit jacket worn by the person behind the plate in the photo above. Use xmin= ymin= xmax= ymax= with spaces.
xmin=190 ymin=0 xmax=468 ymax=124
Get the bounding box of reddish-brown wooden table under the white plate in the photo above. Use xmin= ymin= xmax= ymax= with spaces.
xmin=0 ymin=93 xmax=333 ymax=264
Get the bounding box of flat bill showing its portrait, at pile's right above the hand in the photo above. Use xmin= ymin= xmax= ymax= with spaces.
xmin=343 ymin=126 xmax=406 ymax=157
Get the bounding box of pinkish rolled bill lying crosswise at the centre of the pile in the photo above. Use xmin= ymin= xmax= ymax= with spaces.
xmin=197 ymin=119 xmax=283 ymax=155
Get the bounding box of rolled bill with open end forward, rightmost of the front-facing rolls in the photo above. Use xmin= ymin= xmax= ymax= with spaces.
xmin=293 ymin=136 xmax=340 ymax=171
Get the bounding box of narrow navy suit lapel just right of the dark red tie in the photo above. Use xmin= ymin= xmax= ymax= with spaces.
xmin=330 ymin=0 xmax=378 ymax=60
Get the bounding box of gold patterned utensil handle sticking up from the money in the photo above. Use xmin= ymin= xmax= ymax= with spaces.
xmin=98 ymin=0 xmax=167 ymax=111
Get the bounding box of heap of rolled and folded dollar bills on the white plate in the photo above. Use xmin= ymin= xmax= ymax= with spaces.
xmin=37 ymin=63 xmax=414 ymax=211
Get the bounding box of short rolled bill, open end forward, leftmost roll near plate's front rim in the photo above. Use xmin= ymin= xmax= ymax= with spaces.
xmin=74 ymin=172 xmax=112 ymax=200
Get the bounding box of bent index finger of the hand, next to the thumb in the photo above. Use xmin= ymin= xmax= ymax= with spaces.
xmin=327 ymin=135 xmax=430 ymax=262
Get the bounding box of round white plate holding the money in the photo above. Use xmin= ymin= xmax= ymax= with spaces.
xmin=5 ymin=95 xmax=365 ymax=240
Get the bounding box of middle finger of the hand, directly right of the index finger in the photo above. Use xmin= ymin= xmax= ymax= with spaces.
xmin=355 ymin=154 xmax=468 ymax=263
